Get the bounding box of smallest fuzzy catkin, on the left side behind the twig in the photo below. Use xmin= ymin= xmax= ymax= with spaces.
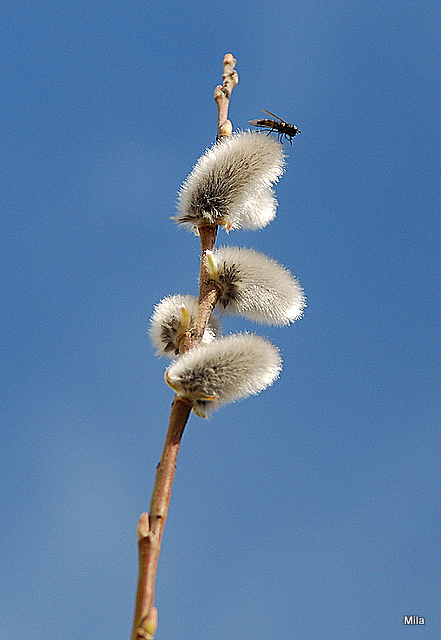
xmin=149 ymin=295 xmax=220 ymax=358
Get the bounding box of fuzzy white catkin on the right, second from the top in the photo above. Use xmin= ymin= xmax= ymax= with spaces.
xmin=209 ymin=247 xmax=306 ymax=325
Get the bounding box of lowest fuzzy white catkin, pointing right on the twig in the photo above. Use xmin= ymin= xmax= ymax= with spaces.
xmin=165 ymin=333 xmax=282 ymax=418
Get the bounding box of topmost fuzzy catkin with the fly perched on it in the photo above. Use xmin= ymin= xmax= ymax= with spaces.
xmin=174 ymin=131 xmax=284 ymax=230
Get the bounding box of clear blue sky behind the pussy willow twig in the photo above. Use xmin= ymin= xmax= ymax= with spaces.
xmin=0 ymin=0 xmax=441 ymax=640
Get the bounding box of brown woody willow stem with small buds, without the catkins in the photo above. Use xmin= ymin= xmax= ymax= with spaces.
xmin=131 ymin=53 xmax=238 ymax=640
